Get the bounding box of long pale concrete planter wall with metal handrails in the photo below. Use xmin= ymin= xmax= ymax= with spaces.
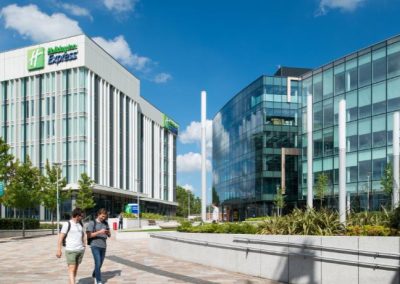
xmin=150 ymin=232 xmax=400 ymax=284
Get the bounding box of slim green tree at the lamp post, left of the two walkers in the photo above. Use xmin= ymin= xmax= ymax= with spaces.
xmin=41 ymin=160 xmax=70 ymax=234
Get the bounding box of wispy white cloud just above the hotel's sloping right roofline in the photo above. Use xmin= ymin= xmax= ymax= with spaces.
xmin=93 ymin=35 xmax=152 ymax=71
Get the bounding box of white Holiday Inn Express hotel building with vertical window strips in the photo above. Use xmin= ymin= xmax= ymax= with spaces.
xmin=0 ymin=35 xmax=178 ymax=219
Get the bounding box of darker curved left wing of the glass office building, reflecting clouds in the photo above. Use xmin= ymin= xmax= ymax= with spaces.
xmin=213 ymin=76 xmax=301 ymax=220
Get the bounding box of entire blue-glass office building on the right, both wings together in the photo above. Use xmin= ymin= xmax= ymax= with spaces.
xmin=213 ymin=36 xmax=400 ymax=219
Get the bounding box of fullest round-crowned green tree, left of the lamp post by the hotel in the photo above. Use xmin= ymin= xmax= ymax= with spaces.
xmin=4 ymin=156 xmax=43 ymax=237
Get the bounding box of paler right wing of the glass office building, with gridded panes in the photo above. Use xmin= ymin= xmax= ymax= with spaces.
xmin=299 ymin=37 xmax=400 ymax=210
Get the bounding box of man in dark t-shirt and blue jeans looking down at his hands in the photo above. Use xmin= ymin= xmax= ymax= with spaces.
xmin=86 ymin=208 xmax=111 ymax=284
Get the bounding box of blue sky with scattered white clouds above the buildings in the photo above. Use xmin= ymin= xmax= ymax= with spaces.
xmin=0 ymin=0 xmax=400 ymax=200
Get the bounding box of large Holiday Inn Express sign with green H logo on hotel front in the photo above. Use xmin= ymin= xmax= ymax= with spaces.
xmin=28 ymin=44 xmax=78 ymax=71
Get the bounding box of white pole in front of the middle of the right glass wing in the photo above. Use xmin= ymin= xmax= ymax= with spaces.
xmin=339 ymin=100 xmax=346 ymax=225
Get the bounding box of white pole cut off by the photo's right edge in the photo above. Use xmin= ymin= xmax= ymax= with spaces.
xmin=392 ymin=111 xmax=400 ymax=209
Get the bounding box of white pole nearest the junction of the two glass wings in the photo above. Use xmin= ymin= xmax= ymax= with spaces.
xmin=307 ymin=95 xmax=313 ymax=209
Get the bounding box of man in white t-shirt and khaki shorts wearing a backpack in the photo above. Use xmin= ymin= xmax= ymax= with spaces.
xmin=56 ymin=208 xmax=85 ymax=284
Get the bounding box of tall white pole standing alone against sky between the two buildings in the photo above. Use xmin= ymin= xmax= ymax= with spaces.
xmin=201 ymin=91 xmax=207 ymax=222
